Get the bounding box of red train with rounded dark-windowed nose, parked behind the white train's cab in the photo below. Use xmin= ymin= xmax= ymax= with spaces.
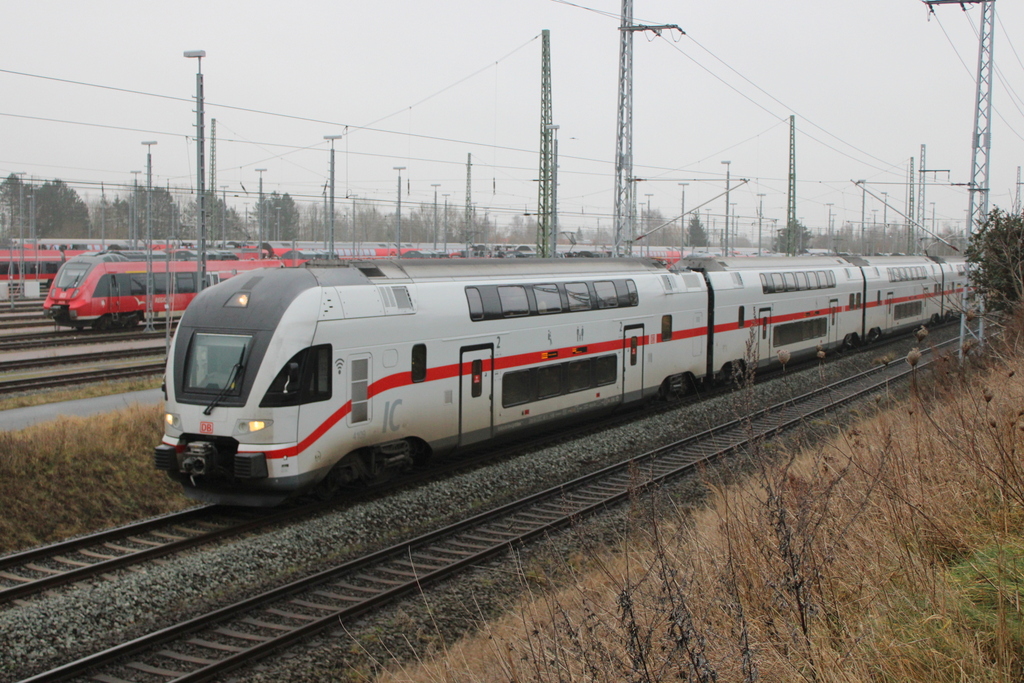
xmin=43 ymin=255 xmax=284 ymax=330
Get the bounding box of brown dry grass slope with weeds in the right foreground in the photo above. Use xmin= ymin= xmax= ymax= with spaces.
xmin=378 ymin=321 xmax=1024 ymax=683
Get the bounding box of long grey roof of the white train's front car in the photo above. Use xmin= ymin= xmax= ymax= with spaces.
xmin=305 ymin=258 xmax=666 ymax=281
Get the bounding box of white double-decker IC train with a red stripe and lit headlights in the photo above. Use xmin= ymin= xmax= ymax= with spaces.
xmin=155 ymin=257 xmax=967 ymax=505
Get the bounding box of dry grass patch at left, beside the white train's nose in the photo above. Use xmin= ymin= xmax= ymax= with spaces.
xmin=0 ymin=405 xmax=190 ymax=553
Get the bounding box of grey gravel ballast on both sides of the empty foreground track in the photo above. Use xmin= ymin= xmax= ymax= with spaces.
xmin=0 ymin=335 xmax=937 ymax=681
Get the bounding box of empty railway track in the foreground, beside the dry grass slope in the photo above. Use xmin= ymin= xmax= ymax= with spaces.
xmin=16 ymin=337 xmax=954 ymax=682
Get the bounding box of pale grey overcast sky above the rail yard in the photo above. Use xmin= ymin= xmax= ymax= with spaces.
xmin=0 ymin=0 xmax=1024 ymax=245
